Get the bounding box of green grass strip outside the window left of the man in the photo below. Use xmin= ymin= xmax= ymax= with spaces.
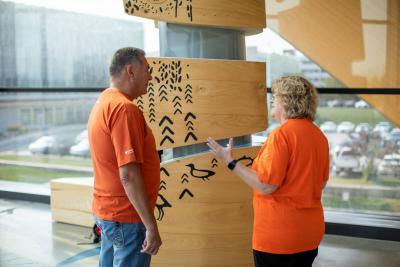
xmin=0 ymin=165 xmax=90 ymax=183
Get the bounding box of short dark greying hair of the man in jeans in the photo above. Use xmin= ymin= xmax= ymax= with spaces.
xmin=109 ymin=47 xmax=145 ymax=77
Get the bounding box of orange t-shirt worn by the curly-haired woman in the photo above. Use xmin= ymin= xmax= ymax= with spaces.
xmin=253 ymin=119 xmax=329 ymax=254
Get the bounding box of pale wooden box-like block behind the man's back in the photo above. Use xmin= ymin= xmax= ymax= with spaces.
xmin=50 ymin=178 xmax=94 ymax=227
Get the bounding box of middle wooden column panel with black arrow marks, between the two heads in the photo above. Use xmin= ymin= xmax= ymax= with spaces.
xmin=135 ymin=58 xmax=267 ymax=149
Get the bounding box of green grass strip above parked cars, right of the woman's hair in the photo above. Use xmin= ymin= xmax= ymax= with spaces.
xmin=316 ymin=107 xmax=387 ymax=126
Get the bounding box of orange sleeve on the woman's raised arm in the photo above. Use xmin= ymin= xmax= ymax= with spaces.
xmin=256 ymin=129 xmax=289 ymax=186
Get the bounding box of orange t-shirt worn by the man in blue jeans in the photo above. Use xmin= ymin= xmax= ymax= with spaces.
xmin=88 ymin=88 xmax=160 ymax=222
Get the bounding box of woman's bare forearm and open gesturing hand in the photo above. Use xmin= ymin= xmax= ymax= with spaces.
xmin=207 ymin=137 xmax=278 ymax=195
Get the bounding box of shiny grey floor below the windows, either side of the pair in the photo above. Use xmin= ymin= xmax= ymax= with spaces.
xmin=0 ymin=199 xmax=400 ymax=267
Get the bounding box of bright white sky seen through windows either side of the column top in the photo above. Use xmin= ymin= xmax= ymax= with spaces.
xmin=5 ymin=0 xmax=292 ymax=53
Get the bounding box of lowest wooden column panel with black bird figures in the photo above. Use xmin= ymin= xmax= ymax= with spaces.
xmin=152 ymin=147 xmax=260 ymax=267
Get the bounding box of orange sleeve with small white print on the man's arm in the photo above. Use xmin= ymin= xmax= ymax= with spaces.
xmin=111 ymin=109 xmax=144 ymax=167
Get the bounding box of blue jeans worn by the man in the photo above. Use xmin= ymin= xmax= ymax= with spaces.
xmin=95 ymin=217 xmax=151 ymax=267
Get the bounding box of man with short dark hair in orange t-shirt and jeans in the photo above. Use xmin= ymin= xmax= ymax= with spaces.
xmin=88 ymin=47 xmax=161 ymax=267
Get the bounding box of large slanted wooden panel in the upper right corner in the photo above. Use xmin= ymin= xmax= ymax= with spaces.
xmin=266 ymin=0 xmax=400 ymax=125
